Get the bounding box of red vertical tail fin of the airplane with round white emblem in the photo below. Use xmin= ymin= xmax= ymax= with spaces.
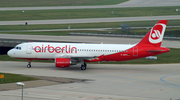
xmin=138 ymin=20 xmax=167 ymax=47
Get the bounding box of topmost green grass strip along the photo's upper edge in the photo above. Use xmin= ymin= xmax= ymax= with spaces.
xmin=0 ymin=0 xmax=129 ymax=7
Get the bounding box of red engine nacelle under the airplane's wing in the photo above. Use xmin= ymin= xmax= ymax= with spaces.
xmin=55 ymin=58 xmax=71 ymax=68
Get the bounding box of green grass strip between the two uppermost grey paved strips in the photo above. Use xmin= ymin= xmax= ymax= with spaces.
xmin=0 ymin=6 xmax=180 ymax=21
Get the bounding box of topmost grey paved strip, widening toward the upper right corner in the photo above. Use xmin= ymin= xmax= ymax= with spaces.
xmin=0 ymin=0 xmax=180 ymax=11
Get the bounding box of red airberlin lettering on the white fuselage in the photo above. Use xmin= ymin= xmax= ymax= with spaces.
xmin=33 ymin=44 xmax=77 ymax=53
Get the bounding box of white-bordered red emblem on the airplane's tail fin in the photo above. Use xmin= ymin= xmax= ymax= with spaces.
xmin=149 ymin=24 xmax=166 ymax=43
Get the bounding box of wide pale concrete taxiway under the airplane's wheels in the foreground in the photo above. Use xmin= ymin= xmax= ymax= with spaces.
xmin=0 ymin=61 xmax=180 ymax=100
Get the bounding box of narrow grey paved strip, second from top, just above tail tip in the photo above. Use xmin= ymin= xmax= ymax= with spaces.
xmin=0 ymin=15 xmax=180 ymax=25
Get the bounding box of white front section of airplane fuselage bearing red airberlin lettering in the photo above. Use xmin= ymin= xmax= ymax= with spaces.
xmin=8 ymin=42 xmax=135 ymax=59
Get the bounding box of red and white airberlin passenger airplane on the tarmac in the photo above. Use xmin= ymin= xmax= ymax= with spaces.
xmin=7 ymin=20 xmax=169 ymax=70
